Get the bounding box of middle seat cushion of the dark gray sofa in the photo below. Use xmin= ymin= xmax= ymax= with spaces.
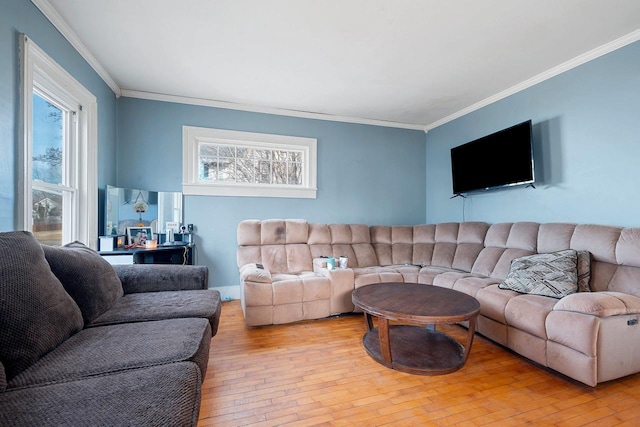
xmin=8 ymin=319 xmax=211 ymax=389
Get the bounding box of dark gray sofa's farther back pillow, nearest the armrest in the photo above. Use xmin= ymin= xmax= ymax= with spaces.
xmin=42 ymin=241 xmax=124 ymax=324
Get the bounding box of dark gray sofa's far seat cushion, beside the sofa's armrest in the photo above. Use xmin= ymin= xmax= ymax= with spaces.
xmin=88 ymin=289 xmax=222 ymax=335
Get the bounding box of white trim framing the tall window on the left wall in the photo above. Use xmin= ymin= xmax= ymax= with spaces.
xmin=17 ymin=34 xmax=98 ymax=249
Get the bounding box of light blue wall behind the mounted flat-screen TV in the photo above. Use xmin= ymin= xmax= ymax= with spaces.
xmin=426 ymin=42 xmax=640 ymax=227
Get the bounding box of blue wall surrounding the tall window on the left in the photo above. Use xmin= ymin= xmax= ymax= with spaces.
xmin=0 ymin=0 xmax=116 ymax=231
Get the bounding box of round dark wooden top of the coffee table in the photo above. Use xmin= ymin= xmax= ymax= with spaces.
xmin=352 ymin=283 xmax=480 ymax=324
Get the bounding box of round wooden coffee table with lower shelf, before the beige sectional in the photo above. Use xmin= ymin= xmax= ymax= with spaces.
xmin=352 ymin=283 xmax=480 ymax=375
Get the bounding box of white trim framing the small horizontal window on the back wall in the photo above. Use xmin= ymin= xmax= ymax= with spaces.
xmin=182 ymin=126 xmax=317 ymax=199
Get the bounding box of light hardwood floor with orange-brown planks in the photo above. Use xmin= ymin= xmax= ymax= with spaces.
xmin=198 ymin=301 xmax=640 ymax=427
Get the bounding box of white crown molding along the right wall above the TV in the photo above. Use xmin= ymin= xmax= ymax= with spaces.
xmin=424 ymin=30 xmax=640 ymax=132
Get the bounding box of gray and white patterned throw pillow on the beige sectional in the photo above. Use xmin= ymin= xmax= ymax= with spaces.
xmin=498 ymin=249 xmax=578 ymax=298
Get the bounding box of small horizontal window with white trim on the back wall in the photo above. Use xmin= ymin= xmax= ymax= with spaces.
xmin=182 ymin=126 xmax=317 ymax=198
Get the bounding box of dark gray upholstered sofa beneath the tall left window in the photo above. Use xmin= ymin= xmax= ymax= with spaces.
xmin=0 ymin=231 xmax=221 ymax=426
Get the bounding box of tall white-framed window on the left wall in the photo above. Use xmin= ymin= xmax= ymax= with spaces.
xmin=18 ymin=36 xmax=98 ymax=248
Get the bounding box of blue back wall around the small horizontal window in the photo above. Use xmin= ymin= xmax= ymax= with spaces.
xmin=118 ymin=97 xmax=425 ymax=292
